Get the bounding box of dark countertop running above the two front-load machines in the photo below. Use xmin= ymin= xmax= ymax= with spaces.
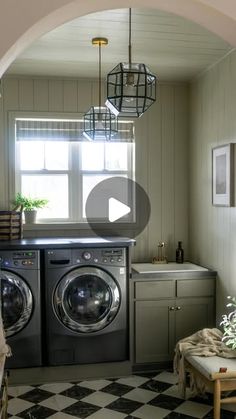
xmin=0 ymin=237 xmax=136 ymax=250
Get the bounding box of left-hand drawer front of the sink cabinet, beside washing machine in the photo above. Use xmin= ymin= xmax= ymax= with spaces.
xmin=135 ymin=281 xmax=175 ymax=300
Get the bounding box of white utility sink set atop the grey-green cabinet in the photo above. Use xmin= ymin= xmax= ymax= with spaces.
xmin=132 ymin=262 xmax=208 ymax=274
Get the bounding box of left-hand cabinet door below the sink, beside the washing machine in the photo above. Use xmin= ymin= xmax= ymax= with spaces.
xmin=135 ymin=300 xmax=176 ymax=363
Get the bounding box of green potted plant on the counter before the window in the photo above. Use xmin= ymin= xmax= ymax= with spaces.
xmin=13 ymin=192 xmax=48 ymax=224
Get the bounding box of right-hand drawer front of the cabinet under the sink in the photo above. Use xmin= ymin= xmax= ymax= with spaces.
xmin=177 ymin=278 xmax=215 ymax=297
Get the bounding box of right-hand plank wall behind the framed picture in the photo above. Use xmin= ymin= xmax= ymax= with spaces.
xmin=190 ymin=52 xmax=236 ymax=325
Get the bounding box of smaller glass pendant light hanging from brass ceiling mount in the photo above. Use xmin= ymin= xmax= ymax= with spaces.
xmin=83 ymin=38 xmax=118 ymax=141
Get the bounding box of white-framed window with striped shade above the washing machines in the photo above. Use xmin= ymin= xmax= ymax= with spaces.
xmin=15 ymin=118 xmax=134 ymax=223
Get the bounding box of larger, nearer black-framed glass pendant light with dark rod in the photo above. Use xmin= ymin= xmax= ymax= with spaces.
xmin=106 ymin=9 xmax=156 ymax=117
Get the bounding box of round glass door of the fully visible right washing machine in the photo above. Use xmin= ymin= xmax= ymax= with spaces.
xmin=53 ymin=266 xmax=121 ymax=333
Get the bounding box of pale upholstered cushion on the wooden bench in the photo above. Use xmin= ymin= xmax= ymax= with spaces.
xmin=186 ymin=356 xmax=236 ymax=380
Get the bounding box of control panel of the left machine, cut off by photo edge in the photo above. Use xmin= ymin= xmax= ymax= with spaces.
xmin=0 ymin=250 xmax=39 ymax=269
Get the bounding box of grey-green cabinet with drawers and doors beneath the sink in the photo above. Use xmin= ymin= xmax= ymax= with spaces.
xmin=133 ymin=278 xmax=215 ymax=364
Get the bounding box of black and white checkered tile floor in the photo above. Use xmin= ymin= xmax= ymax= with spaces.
xmin=8 ymin=371 xmax=236 ymax=419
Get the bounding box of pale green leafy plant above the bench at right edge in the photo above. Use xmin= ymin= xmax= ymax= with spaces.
xmin=220 ymin=296 xmax=236 ymax=349
